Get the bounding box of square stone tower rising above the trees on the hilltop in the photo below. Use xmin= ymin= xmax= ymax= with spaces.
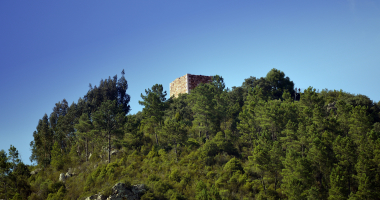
xmin=170 ymin=74 xmax=212 ymax=97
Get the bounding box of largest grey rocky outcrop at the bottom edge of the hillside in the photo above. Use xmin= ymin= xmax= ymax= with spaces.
xmin=86 ymin=183 xmax=146 ymax=200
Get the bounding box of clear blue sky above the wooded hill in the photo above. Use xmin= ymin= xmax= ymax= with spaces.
xmin=0 ymin=0 xmax=380 ymax=164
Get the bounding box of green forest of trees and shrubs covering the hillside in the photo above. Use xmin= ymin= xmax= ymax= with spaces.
xmin=0 ymin=69 xmax=380 ymax=200
